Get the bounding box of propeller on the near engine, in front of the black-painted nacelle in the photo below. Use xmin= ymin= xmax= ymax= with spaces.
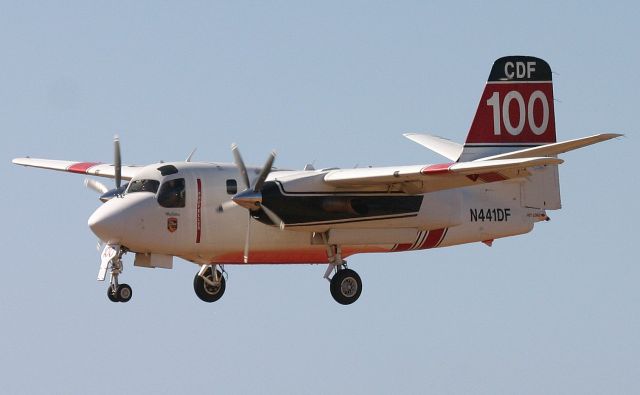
xmin=218 ymin=144 xmax=285 ymax=263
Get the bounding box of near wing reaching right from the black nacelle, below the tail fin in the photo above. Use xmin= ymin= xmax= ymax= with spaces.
xmin=324 ymin=157 xmax=563 ymax=193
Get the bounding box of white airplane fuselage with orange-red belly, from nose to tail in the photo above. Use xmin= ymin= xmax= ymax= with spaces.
xmin=89 ymin=162 xmax=546 ymax=264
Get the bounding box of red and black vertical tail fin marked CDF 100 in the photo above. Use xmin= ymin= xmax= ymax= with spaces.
xmin=459 ymin=56 xmax=556 ymax=161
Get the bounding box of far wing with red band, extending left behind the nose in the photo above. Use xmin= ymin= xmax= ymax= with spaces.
xmin=12 ymin=158 xmax=142 ymax=181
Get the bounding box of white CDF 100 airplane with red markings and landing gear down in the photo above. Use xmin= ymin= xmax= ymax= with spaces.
xmin=13 ymin=56 xmax=622 ymax=305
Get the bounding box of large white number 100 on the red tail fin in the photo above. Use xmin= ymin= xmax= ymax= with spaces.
xmin=487 ymin=91 xmax=549 ymax=136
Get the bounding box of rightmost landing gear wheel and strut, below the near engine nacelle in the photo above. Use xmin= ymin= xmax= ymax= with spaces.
xmin=324 ymin=244 xmax=362 ymax=305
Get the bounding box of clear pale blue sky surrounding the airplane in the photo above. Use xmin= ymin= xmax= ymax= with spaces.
xmin=0 ymin=1 xmax=640 ymax=394
